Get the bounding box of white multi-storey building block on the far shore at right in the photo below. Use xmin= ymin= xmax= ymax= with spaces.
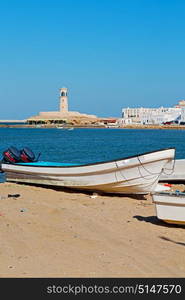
xmin=122 ymin=100 xmax=182 ymax=125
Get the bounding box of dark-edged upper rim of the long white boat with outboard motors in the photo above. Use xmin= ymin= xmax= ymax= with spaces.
xmin=1 ymin=148 xmax=176 ymax=168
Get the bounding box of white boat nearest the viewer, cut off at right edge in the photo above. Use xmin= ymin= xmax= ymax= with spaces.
xmin=152 ymin=192 xmax=185 ymax=224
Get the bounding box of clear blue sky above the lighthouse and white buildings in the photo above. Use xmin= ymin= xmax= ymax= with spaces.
xmin=0 ymin=0 xmax=185 ymax=120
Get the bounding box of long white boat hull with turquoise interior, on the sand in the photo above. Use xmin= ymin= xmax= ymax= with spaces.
xmin=1 ymin=148 xmax=175 ymax=194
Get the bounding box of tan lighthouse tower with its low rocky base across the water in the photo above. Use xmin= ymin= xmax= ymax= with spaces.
xmin=27 ymin=87 xmax=98 ymax=125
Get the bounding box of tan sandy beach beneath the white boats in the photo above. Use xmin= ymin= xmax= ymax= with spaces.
xmin=0 ymin=183 xmax=185 ymax=278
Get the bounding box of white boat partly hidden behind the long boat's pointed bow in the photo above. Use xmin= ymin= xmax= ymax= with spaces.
xmin=160 ymin=159 xmax=185 ymax=182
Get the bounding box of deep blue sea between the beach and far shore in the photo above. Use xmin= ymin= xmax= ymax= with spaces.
xmin=0 ymin=127 xmax=185 ymax=182
